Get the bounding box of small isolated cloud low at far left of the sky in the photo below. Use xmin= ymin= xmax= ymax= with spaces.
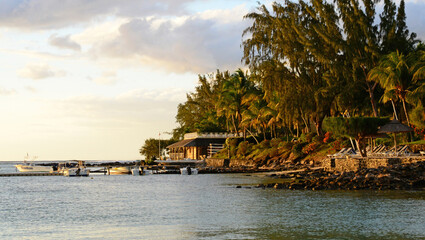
xmin=18 ymin=63 xmax=66 ymax=80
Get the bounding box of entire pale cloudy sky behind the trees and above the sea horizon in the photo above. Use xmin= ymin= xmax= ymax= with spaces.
xmin=0 ymin=0 xmax=425 ymax=161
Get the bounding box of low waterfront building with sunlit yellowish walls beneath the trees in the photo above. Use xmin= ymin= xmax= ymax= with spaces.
xmin=167 ymin=132 xmax=234 ymax=160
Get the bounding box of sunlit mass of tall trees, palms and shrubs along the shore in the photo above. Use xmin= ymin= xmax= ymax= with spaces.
xmin=142 ymin=0 xmax=425 ymax=159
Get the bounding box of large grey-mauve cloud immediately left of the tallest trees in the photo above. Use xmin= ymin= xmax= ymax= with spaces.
xmin=92 ymin=7 xmax=248 ymax=73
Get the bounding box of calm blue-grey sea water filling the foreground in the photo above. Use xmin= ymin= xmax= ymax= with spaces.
xmin=0 ymin=162 xmax=425 ymax=239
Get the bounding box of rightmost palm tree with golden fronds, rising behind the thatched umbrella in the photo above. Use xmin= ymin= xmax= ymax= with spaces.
xmin=368 ymin=51 xmax=413 ymax=125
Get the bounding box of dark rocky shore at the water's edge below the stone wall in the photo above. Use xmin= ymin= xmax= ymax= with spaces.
xmin=253 ymin=161 xmax=425 ymax=190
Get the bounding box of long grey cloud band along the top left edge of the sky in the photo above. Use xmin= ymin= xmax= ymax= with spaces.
xmin=0 ymin=0 xmax=194 ymax=29
